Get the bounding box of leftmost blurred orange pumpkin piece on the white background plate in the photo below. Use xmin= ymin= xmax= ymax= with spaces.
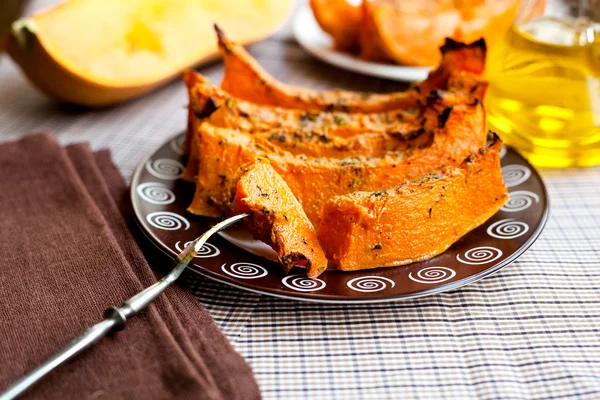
xmin=310 ymin=0 xmax=362 ymax=50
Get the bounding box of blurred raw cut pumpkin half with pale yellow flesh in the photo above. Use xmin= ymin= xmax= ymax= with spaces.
xmin=6 ymin=0 xmax=294 ymax=107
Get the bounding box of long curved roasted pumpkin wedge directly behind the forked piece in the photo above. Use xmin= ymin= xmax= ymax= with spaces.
xmin=188 ymin=95 xmax=486 ymax=226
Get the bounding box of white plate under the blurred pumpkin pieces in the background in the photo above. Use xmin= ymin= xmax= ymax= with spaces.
xmin=293 ymin=7 xmax=430 ymax=81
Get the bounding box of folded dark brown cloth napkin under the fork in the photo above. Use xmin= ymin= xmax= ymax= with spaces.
xmin=0 ymin=134 xmax=260 ymax=399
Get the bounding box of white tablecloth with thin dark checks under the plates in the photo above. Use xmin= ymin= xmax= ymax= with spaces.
xmin=0 ymin=1 xmax=600 ymax=399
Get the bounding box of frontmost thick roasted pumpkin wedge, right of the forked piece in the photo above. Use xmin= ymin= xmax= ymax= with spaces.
xmin=318 ymin=135 xmax=508 ymax=271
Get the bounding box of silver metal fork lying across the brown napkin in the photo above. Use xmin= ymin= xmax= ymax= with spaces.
xmin=0 ymin=214 xmax=250 ymax=400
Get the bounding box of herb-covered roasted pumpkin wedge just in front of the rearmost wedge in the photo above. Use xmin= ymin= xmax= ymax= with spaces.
xmin=183 ymin=72 xmax=482 ymax=181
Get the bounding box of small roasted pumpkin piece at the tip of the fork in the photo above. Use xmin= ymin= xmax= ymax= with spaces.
xmin=232 ymin=158 xmax=327 ymax=278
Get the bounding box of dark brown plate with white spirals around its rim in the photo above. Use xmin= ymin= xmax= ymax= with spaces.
xmin=131 ymin=133 xmax=548 ymax=303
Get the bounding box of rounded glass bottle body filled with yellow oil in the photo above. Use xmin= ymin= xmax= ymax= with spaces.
xmin=486 ymin=17 xmax=600 ymax=167
